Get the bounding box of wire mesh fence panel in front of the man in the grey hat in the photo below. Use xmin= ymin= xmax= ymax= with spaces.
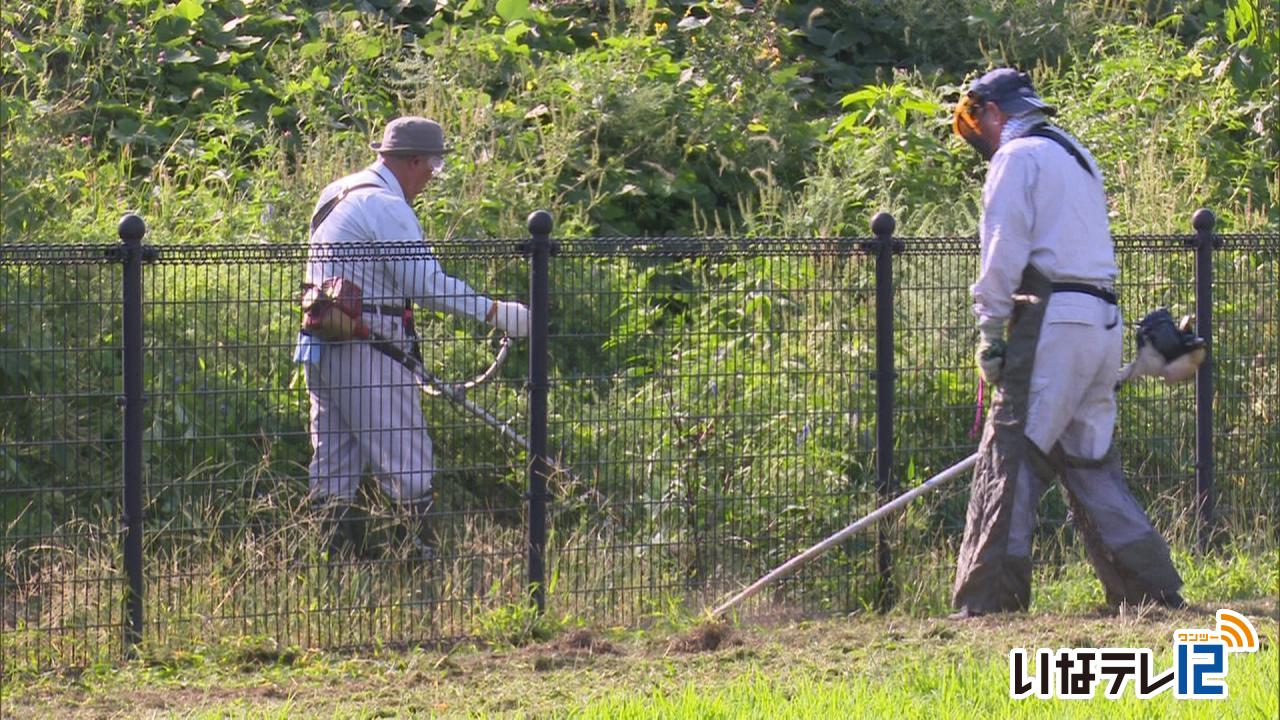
xmin=132 ymin=243 xmax=525 ymax=648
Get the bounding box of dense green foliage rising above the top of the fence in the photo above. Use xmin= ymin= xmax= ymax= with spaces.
xmin=0 ymin=0 xmax=1280 ymax=242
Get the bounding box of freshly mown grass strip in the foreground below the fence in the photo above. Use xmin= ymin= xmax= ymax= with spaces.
xmin=0 ymin=551 xmax=1280 ymax=719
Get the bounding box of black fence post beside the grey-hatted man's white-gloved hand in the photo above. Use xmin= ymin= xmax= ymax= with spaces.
xmin=526 ymin=210 xmax=556 ymax=612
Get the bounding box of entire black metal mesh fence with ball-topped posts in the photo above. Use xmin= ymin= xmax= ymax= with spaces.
xmin=0 ymin=214 xmax=1280 ymax=669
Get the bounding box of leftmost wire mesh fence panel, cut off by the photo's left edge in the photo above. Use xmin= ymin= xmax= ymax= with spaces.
xmin=0 ymin=245 xmax=124 ymax=671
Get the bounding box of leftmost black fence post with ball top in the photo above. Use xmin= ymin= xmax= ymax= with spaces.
xmin=116 ymin=213 xmax=150 ymax=655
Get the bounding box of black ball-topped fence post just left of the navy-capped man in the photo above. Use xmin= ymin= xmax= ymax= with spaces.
xmin=865 ymin=213 xmax=902 ymax=611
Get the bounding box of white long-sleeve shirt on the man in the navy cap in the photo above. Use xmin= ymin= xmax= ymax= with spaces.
xmin=970 ymin=130 xmax=1117 ymax=325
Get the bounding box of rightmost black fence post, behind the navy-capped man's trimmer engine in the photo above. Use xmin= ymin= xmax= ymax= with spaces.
xmin=1189 ymin=208 xmax=1222 ymax=552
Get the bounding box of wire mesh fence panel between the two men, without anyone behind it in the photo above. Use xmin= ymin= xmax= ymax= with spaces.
xmin=549 ymin=238 xmax=876 ymax=623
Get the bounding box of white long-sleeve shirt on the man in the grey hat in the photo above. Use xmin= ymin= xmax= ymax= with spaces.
xmin=306 ymin=160 xmax=493 ymax=322
